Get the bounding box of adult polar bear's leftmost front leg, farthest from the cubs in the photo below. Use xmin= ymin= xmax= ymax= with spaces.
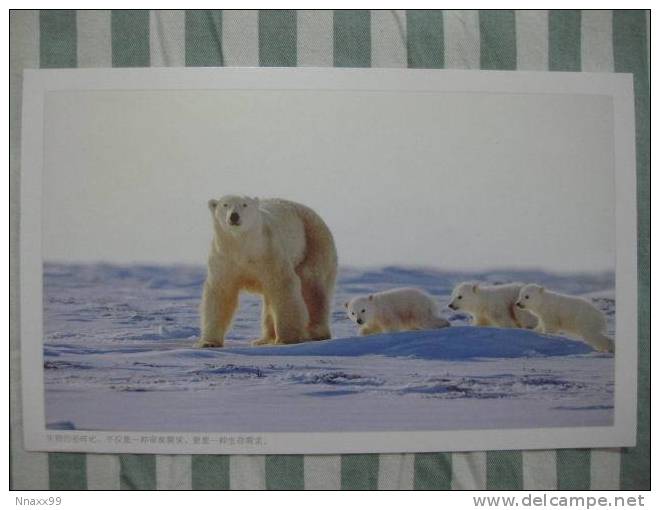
xmin=196 ymin=279 xmax=238 ymax=347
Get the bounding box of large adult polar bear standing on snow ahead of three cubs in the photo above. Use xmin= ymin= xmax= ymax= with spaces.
xmin=197 ymin=195 xmax=337 ymax=347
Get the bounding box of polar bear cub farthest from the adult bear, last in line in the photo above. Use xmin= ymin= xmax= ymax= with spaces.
xmin=516 ymin=284 xmax=614 ymax=352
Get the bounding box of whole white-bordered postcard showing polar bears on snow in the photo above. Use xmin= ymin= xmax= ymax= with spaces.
xmin=20 ymin=68 xmax=637 ymax=454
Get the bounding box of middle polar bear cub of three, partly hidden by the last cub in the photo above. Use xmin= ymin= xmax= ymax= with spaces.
xmin=449 ymin=282 xmax=537 ymax=329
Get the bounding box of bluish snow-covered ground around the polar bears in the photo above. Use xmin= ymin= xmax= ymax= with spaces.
xmin=44 ymin=264 xmax=615 ymax=432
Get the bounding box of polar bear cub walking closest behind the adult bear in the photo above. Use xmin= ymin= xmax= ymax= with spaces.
xmin=344 ymin=288 xmax=449 ymax=335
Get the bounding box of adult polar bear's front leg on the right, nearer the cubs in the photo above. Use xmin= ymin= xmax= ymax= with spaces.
xmin=266 ymin=270 xmax=309 ymax=344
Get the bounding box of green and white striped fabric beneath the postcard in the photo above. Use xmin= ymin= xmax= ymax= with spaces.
xmin=10 ymin=11 xmax=650 ymax=489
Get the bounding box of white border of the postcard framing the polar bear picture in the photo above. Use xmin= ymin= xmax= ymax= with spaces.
xmin=20 ymin=68 xmax=637 ymax=454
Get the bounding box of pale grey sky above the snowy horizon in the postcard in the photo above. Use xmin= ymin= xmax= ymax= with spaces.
xmin=43 ymin=90 xmax=615 ymax=271
